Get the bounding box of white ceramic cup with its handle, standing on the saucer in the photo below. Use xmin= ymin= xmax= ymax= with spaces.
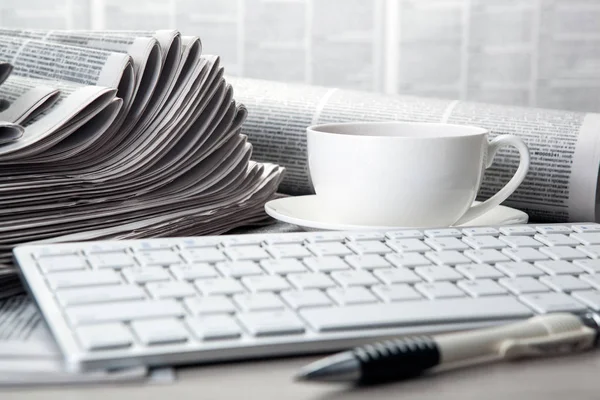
xmin=307 ymin=122 xmax=529 ymax=227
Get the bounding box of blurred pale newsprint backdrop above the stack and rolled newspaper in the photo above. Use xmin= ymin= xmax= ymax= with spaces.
xmin=0 ymin=0 xmax=600 ymax=112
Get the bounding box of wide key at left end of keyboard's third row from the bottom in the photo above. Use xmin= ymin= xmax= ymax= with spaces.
xmin=56 ymin=285 xmax=146 ymax=307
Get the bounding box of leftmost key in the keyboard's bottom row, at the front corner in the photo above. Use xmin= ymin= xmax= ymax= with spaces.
xmin=75 ymin=323 xmax=133 ymax=351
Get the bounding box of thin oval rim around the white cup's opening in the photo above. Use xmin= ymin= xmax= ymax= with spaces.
xmin=306 ymin=121 xmax=490 ymax=140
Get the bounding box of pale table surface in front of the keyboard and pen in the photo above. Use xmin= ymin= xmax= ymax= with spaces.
xmin=0 ymin=352 xmax=600 ymax=400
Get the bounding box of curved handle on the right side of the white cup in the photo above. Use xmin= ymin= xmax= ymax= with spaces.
xmin=454 ymin=135 xmax=530 ymax=226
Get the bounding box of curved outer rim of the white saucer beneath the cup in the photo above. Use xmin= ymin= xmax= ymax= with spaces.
xmin=264 ymin=194 xmax=529 ymax=231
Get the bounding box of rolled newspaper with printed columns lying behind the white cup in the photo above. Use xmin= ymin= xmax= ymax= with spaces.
xmin=230 ymin=78 xmax=600 ymax=222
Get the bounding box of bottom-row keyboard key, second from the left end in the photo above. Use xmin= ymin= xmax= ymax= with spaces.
xmin=131 ymin=318 xmax=188 ymax=346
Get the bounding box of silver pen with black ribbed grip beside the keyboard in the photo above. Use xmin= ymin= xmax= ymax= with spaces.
xmin=295 ymin=313 xmax=600 ymax=384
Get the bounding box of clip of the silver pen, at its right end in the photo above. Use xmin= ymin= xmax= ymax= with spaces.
xmin=498 ymin=327 xmax=596 ymax=359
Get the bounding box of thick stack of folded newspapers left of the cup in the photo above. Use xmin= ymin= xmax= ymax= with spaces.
xmin=0 ymin=29 xmax=283 ymax=295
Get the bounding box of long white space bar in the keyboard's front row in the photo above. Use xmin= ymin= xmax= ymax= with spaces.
xmin=300 ymin=296 xmax=533 ymax=332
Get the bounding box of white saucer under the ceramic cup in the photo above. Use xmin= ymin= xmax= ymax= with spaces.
xmin=265 ymin=195 xmax=529 ymax=231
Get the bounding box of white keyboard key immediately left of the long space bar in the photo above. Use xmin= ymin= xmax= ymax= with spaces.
xmin=238 ymin=308 xmax=304 ymax=336
